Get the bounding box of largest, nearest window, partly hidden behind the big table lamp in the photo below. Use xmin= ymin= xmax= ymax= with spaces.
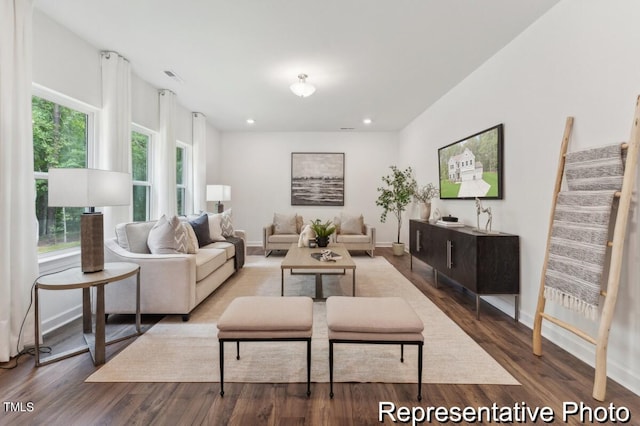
xmin=31 ymin=90 xmax=94 ymax=254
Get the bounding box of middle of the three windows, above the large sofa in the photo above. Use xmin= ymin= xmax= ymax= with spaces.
xmin=131 ymin=125 xmax=151 ymax=221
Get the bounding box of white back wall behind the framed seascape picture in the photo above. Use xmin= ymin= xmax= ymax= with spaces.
xmin=221 ymin=132 xmax=397 ymax=246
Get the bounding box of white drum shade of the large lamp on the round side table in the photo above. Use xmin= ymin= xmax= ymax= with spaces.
xmin=49 ymin=168 xmax=132 ymax=207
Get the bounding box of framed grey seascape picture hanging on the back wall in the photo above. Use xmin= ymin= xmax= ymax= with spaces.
xmin=291 ymin=152 xmax=344 ymax=206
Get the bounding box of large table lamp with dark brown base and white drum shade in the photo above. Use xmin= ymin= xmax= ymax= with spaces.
xmin=49 ymin=168 xmax=132 ymax=273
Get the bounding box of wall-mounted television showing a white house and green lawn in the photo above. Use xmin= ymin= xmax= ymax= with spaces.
xmin=438 ymin=124 xmax=503 ymax=200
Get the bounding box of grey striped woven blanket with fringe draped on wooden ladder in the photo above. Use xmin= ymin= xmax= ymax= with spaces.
xmin=544 ymin=144 xmax=624 ymax=320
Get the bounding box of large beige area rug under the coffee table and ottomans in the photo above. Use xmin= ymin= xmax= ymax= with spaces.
xmin=86 ymin=256 xmax=519 ymax=385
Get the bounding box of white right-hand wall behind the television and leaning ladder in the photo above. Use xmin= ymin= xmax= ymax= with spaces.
xmin=399 ymin=0 xmax=640 ymax=393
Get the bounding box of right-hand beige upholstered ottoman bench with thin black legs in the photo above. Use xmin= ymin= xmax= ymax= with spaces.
xmin=327 ymin=296 xmax=424 ymax=401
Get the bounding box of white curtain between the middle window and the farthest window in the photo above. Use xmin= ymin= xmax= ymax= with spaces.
xmin=153 ymin=89 xmax=177 ymax=218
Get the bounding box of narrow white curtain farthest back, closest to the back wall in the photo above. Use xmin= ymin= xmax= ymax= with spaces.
xmin=193 ymin=112 xmax=207 ymax=213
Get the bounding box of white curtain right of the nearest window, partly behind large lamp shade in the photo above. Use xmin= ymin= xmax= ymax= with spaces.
xmin=95 ymin=52 xmax=133 ymax=238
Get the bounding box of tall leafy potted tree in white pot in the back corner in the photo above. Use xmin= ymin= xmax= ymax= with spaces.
xmin=376 ymin=166 xmax=417 ymax=256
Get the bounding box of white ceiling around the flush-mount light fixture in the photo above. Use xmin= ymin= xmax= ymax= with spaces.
xmin=36 ymin=0 xmax=559 ymax=131
